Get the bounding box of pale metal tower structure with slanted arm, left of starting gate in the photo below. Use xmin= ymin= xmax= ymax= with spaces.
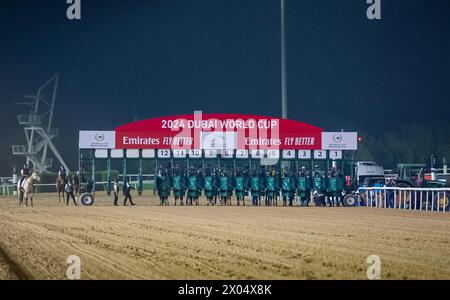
xmin=12 ymin=74 xmax=69 ymax=172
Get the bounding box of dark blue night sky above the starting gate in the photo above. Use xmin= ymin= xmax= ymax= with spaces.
xmin=0 ymin=0 xmax=450 ymax=169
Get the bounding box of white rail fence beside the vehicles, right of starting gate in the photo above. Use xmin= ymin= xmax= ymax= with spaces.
xmin=358 ymin=187 xmax=450 ymax=212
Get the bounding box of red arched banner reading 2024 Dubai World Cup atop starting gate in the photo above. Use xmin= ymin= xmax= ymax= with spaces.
xmin=116 ymin=113 xmax=322 ymax=150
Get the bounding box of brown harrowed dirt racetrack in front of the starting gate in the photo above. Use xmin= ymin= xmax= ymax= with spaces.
xmin=0 ymin=193 xmax=450 ymax=279
